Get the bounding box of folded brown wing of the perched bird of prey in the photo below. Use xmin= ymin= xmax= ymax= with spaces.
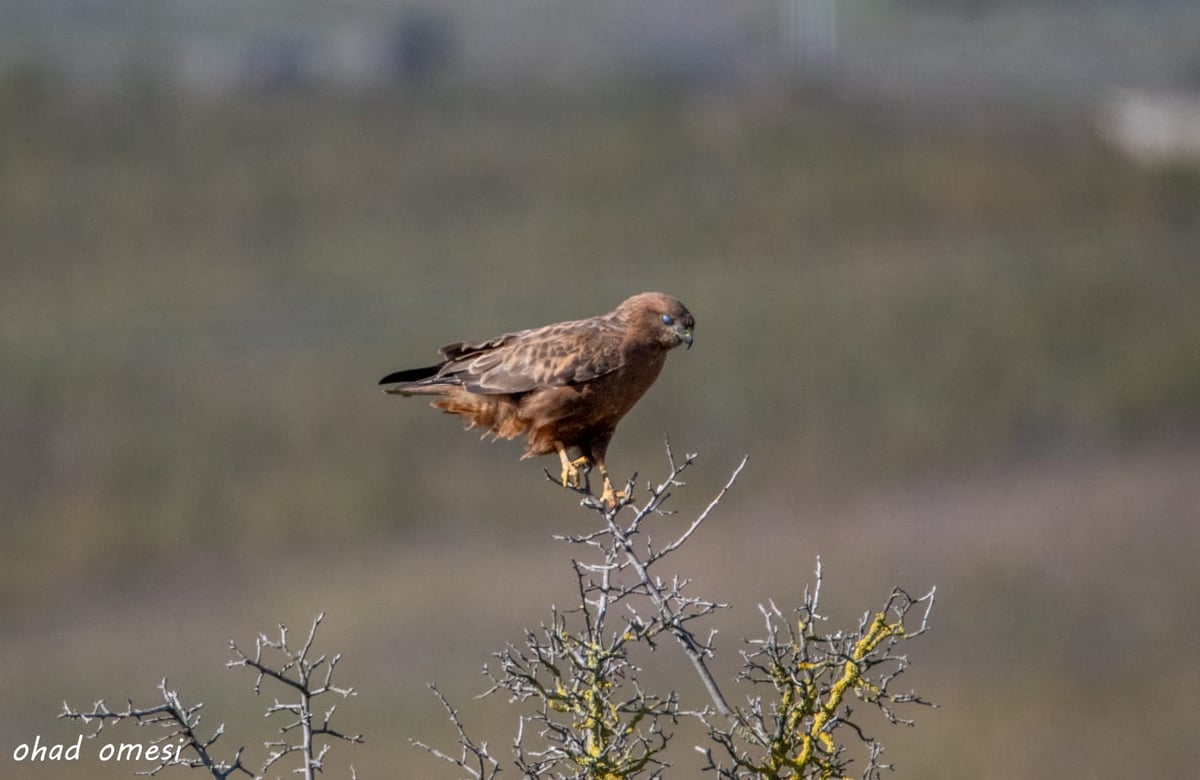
xmin=438 ymin=317 xmax=623 ymax=395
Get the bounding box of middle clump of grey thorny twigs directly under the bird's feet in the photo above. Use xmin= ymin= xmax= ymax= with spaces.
xmin=425 ymin=442 xmax=746 ymax=778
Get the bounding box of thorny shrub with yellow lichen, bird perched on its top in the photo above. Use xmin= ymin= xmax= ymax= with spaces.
xmin=420 ymin=442 xmax=934 ymax=780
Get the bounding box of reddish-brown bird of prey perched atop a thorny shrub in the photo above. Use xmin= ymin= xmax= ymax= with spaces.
xmin=379 ymin=293 xmax=696 ymax=505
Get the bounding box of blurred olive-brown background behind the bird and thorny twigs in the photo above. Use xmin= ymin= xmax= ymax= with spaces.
xmin=0 ymin=0 xmax=1200 ymax=780
